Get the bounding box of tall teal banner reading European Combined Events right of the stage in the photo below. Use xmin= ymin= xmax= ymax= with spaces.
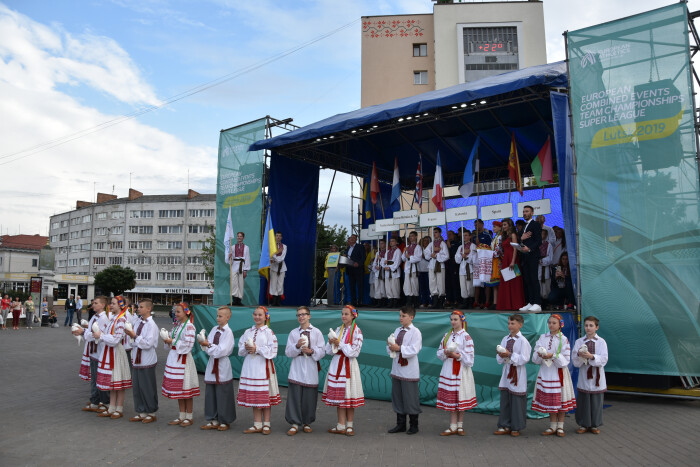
xmin=567 ymin=2 xmax=700 ymax=376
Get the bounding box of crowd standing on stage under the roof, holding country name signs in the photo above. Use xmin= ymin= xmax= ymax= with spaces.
xmin=326 ymin=206 xmax=576 ymax=312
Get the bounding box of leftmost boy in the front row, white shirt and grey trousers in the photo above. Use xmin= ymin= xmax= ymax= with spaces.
xmin=73 ymin=297 xmax=109 ymax=412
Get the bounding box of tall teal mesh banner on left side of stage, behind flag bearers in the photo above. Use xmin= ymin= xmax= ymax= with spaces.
xmin=214 ymin=118 xmax=267 ymax=305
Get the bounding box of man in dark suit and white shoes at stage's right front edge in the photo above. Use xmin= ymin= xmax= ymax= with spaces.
xmin=520 ymin=206 xmax=542 ymax=312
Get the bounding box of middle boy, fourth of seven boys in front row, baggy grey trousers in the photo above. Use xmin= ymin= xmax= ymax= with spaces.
xmin=284 ymin=306 xmax=326 ymax=436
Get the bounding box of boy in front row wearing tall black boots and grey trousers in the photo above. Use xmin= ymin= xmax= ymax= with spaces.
xmin=386 ymin=306 xmax=423 ymax=435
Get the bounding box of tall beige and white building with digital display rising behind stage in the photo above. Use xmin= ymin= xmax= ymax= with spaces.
xmin=361 ymin=1 xmax=547 ymax=107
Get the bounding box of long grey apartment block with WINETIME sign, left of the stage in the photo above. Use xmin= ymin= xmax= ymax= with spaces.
xmin=49 ymin=189 xmax=216 ymax=305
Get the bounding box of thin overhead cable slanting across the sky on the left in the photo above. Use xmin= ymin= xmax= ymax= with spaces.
xmin=0 ymin=18 xmax=360 ymax=165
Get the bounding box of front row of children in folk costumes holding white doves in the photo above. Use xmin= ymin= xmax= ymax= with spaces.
xmin=71 ymin=300 xmax=608 ymax=437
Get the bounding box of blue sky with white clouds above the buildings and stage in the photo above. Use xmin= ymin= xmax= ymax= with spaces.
xmin=0 ymin=0 xmax=700 ymax=235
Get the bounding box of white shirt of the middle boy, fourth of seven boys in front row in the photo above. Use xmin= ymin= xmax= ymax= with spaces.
xmin=284 ymin=324 xmax=326 ymax=387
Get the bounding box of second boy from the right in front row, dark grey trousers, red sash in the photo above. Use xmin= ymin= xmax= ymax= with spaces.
xmin=493 ymin=314 xmax=532 ymax=436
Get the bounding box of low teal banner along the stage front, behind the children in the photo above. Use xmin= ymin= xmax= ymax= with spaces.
xmin=192 ymin=305 xmax=564 ymax=418
